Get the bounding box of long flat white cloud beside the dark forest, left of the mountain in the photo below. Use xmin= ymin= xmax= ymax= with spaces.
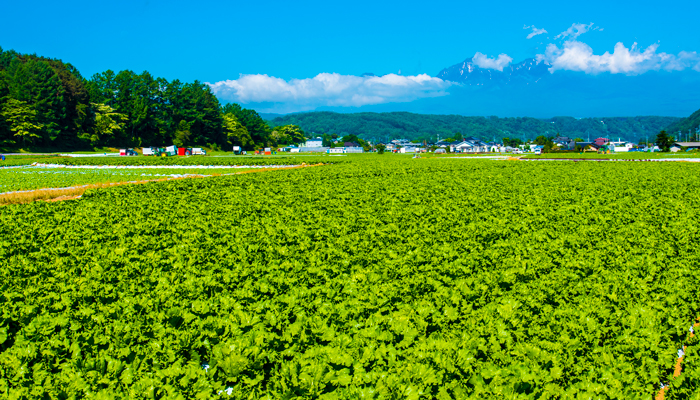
xmin=209 ymin=73 xmax=453 ymax=112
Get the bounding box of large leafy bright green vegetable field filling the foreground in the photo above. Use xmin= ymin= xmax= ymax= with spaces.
xmin=0 ymin=156 xmax=700 ymax=400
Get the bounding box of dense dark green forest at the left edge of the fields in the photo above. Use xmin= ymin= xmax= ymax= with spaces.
xmin=0 ymin=48 xmax=305 ymax=150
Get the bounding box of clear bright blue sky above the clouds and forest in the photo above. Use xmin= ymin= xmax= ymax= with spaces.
xmin=0 ymin=0 xmax=700 ymax=114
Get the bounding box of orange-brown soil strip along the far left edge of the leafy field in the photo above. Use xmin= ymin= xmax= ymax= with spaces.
xmin=0 ymin=163 xmax=323 ymax=206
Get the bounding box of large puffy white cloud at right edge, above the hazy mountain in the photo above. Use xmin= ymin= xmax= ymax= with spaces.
xmin=537 ymin=23 xmax=700 ymax=75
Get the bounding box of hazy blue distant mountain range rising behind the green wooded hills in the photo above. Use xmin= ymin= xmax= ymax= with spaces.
xmin=332 ymin=58 xmax=700 ymax=118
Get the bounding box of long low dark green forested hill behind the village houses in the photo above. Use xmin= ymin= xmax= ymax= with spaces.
xmin=269 ymin=111 xmax=679 ymax=141
